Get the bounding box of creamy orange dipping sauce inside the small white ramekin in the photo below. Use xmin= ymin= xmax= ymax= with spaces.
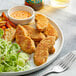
xmin=10 ymin=10 xmax=31 ymax=19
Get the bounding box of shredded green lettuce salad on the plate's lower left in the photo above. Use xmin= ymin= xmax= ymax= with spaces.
xmin=0 ymin=29 xmax=30 ymax=72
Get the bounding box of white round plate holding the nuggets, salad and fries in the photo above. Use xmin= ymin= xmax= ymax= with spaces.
xmin=0 ymin=10 xmax=64 ymax=76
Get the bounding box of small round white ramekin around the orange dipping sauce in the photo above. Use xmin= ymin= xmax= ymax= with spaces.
xmin=8 ymin=6 xmax=35 ymax=24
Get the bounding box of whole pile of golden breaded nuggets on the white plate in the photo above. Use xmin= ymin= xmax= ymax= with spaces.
xmin=4 ymin=14 xmax=58 ymax=66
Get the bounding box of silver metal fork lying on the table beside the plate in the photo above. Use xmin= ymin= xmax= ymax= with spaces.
xmin=42 ymin=52 xmax=76 ymax=76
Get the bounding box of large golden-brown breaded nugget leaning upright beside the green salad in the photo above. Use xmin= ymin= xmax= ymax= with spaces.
xmin=16 ymin=25 xmax=35 ymax=54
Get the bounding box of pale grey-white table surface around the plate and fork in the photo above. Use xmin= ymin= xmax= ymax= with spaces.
xmin=0 ymin=0 xmax=76 ymax=76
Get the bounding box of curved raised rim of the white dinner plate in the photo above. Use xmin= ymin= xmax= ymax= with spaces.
xmin=0 ymin=9 xmax=64 ymax=76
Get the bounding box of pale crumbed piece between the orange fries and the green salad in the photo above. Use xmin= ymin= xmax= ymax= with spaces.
xmin=4 ymin=28 xmax=16 ymax=41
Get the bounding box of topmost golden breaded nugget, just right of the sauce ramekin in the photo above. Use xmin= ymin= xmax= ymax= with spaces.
xmin=35 ymin=14 xmax=49 ymax=31
